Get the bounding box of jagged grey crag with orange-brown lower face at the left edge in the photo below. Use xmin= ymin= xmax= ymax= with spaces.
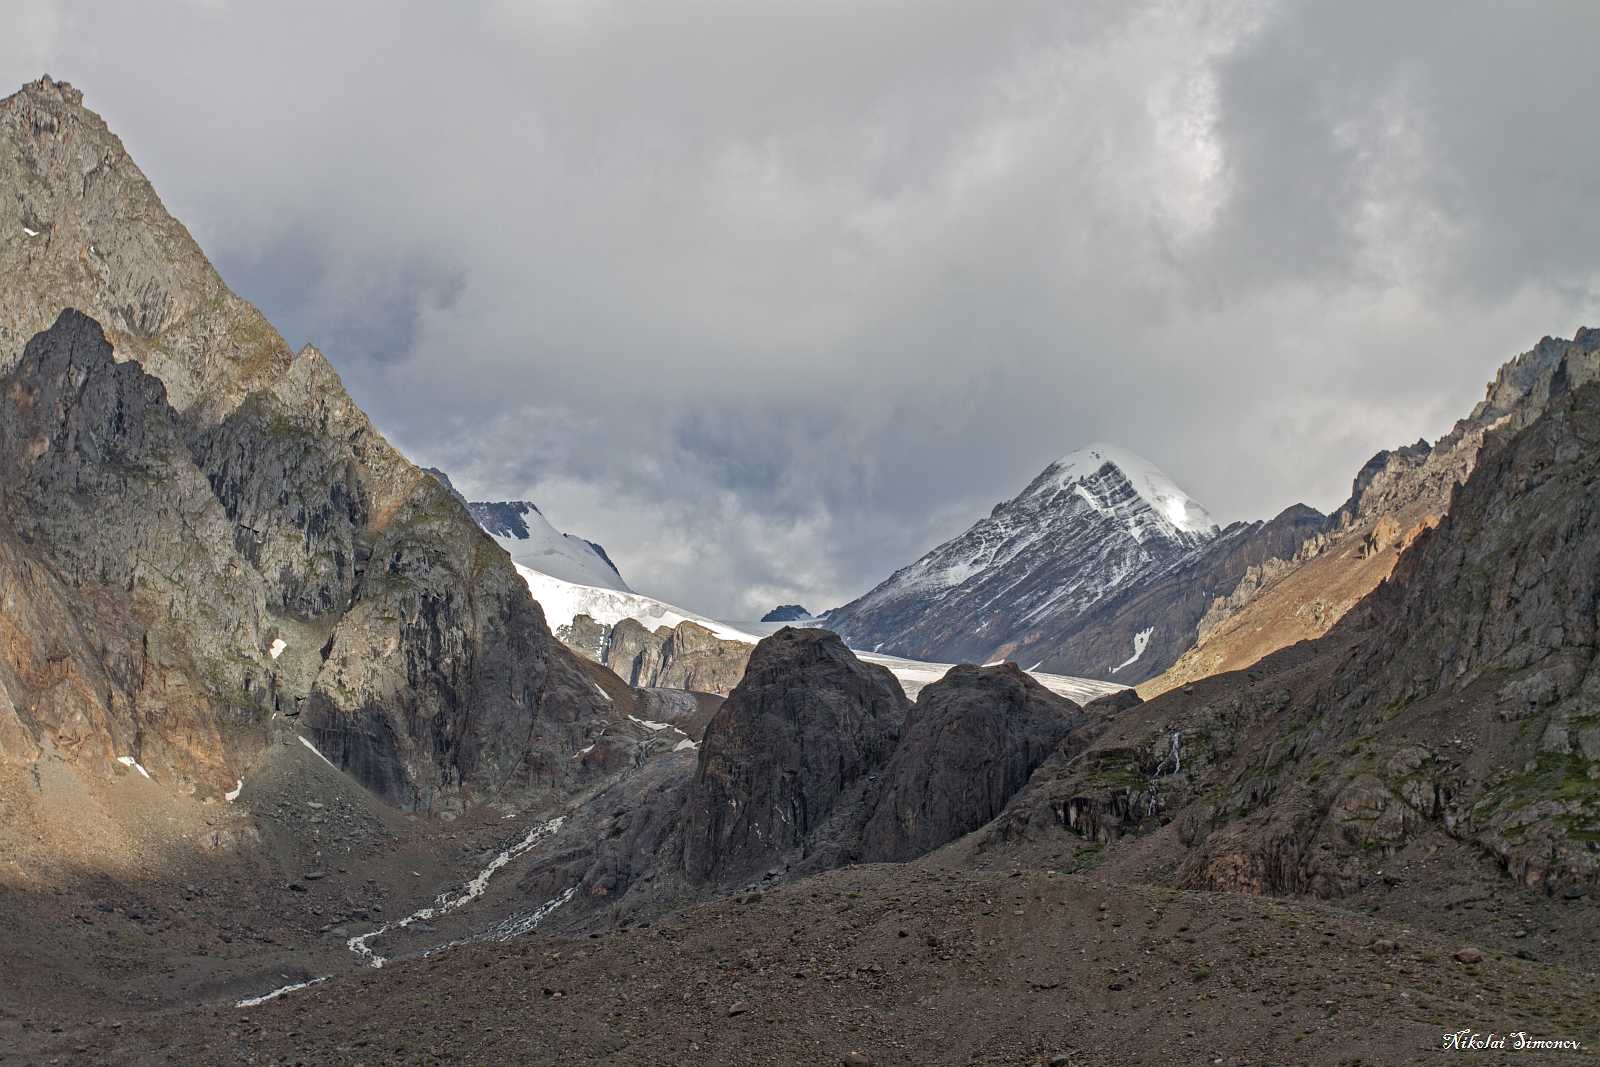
xmin=0 ymin=310 xmax=275 ymax=792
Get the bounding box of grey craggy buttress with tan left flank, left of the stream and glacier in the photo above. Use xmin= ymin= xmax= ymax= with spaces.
xmin=304 ymin=478 xmax=608 ymax=808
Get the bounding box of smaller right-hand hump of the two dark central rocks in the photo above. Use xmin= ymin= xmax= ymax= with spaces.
xmin=861 ymin=664 xmax=1085 ymax=862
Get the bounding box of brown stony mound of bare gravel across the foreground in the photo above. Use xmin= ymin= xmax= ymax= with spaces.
xmin=0 ymin=862 xmax=1600 ymax=1065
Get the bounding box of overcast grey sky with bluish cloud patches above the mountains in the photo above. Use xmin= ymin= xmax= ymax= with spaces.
xmin=0 ymin=0 xmax=1600 ymax=619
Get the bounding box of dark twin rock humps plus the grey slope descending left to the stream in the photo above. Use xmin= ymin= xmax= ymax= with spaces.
xmin=526 ymin=627 xmax=1107 ymax=921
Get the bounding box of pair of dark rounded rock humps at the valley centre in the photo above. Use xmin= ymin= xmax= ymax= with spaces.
xmin=665 ymin=627 xmax=1100 ymax=883
